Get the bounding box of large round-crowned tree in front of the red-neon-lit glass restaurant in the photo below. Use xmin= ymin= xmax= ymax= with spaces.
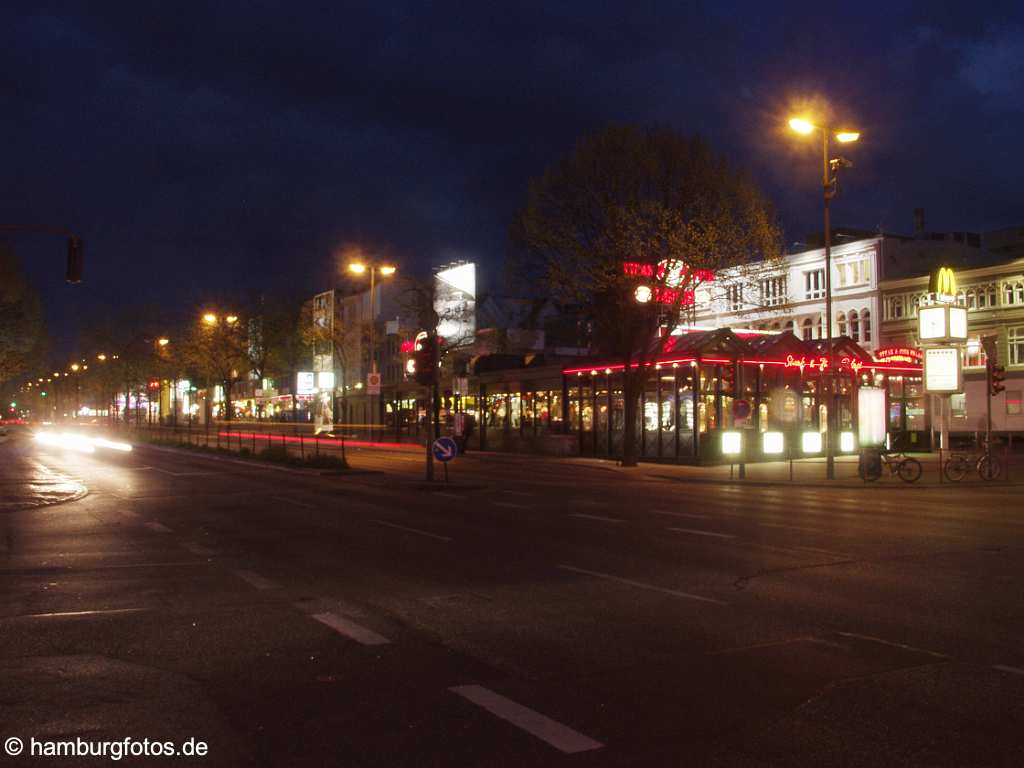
xmin=511 ymin=126 xmax=781 ymax=466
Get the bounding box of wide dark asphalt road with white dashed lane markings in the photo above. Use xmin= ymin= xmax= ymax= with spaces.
xmin=0 ymin=430 xmax=1024 ymax=766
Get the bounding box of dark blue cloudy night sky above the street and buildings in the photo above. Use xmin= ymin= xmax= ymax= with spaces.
xmin=8 ymin=1 xmax=1024 ymax=354
